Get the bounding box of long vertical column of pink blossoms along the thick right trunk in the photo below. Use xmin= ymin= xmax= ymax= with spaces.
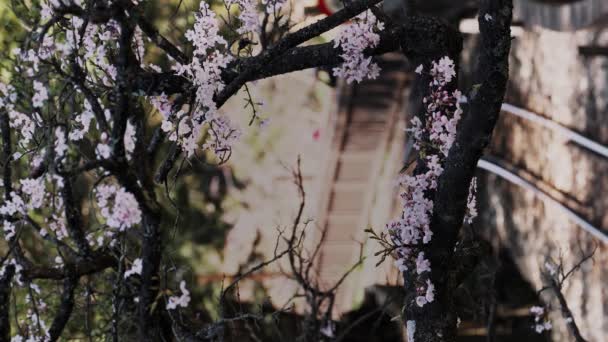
xmin=387 ymin=57 xmax=477 ymax=307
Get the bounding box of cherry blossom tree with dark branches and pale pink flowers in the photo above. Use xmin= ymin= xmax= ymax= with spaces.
xmin=0 ymin=0 xmax=512 ymax=341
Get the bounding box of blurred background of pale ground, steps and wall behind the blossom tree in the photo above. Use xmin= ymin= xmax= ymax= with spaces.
xmin=0 ymin=0 xmax=608 ymax=342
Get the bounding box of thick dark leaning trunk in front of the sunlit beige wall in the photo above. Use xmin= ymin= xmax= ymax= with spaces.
xmin=405 ymin=0 xmax=512 ymax=342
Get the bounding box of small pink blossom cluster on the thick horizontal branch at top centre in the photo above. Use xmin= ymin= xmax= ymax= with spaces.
xmin=333 ymin=10 xmax=384 ymax=83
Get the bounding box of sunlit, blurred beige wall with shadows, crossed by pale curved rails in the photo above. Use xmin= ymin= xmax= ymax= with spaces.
xmin=478 ymin=25 xmax=608 ymax=342
